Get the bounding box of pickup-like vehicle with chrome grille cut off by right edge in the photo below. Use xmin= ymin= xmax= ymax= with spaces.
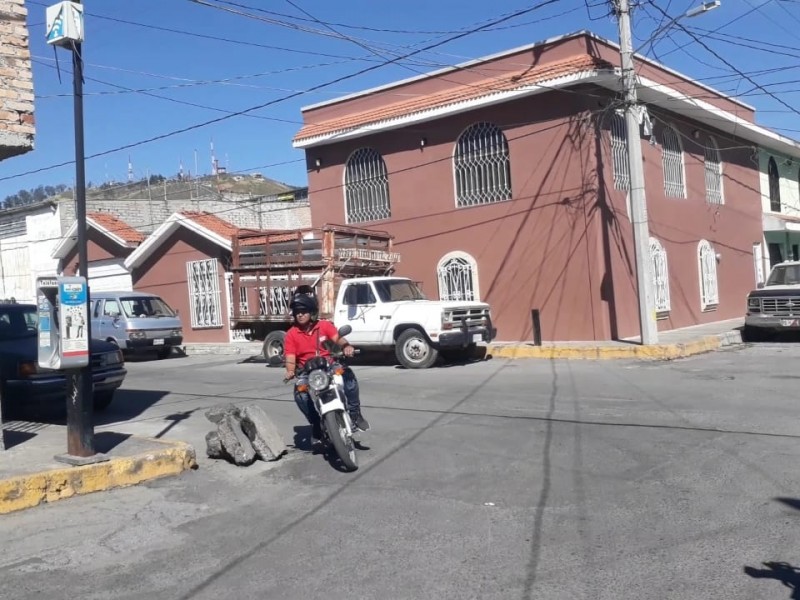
xmin=744 ymin=261 xmax=800 ymax=340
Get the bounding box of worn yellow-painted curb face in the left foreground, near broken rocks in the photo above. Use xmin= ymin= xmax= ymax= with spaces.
xmin=0 ymin=438 xmax=197 ymax=514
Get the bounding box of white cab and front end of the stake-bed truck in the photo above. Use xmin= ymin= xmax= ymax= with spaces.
xmin=333 ymin=277 xmax=496 ymax=369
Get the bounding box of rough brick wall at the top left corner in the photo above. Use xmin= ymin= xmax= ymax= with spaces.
xmin=0 ymin=0 xmax=34 ymax=160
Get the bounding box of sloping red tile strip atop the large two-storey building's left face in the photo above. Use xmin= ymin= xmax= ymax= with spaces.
xmin=294 ymin=55 xmax=613 ymax=141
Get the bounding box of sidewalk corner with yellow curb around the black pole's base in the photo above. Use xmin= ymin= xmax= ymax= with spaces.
xmin=0 ymin=421 xmax=197 ymax=514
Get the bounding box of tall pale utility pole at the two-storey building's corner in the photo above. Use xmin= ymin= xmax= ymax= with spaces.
xmin=618 ymin=0 xmax=658 ymax=345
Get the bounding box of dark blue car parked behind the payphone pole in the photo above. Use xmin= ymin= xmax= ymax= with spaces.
xmin=0 ymin=303 xmax=127 ymax=418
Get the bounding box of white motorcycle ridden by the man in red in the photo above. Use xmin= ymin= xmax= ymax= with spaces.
xmin=278 ymin=325 xmax=358 ymax=471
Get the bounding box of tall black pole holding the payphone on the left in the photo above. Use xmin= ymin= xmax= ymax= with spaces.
xmin=67 ymin=24 xmax=95 ymax=457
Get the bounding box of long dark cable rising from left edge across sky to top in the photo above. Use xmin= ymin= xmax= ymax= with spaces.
xmin=0 ymin=0 xmax=559 ymax=181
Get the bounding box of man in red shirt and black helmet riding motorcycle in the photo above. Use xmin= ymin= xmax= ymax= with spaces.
xmin=283 ymin=289 xmax=369 ymax=440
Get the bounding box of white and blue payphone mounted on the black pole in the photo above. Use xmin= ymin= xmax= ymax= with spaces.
xmin=36 ymin=277 xmax=89 ymax=369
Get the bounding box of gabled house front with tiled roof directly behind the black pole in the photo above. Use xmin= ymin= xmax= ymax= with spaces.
xmin=53 ymin=211 xmax=145 ymax=292
